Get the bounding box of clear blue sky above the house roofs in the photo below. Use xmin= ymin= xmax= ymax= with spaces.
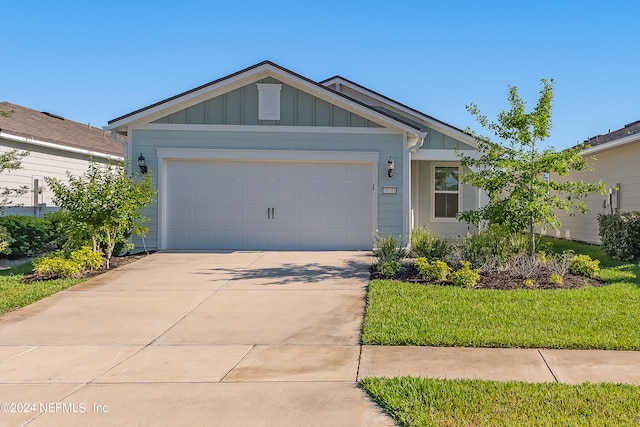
xmin=0 ymin=0 xmax=640 ymax=149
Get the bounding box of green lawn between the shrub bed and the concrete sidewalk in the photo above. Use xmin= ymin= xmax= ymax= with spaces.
xmin=362 ymin=239 xmax=640 ymax=350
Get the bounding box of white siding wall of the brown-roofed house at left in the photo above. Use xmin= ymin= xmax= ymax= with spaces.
xmin=0 ymin=139 xmax=117 ymax=215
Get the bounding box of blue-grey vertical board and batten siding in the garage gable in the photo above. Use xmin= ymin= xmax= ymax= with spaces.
xmin=153 ymin=78 xmax=381 ymax=128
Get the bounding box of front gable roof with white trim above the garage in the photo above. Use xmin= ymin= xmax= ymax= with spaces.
xmin=108 ymin=61 xmax=420 ymax=135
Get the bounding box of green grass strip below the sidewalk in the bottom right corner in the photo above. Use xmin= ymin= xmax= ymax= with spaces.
xmin=360 ymin=377 xmax=640 ymax=426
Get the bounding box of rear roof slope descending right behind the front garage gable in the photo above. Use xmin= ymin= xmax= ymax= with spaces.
xmin=320 ymin=75 xmax=477 ymax=146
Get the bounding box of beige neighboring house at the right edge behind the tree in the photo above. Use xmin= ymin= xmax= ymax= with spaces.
xmin=546 ymin=120 xmax=640 ymax=244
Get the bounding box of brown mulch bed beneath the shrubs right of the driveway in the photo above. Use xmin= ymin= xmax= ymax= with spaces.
xmin=369 ymin=260 xmax=607 ymax=290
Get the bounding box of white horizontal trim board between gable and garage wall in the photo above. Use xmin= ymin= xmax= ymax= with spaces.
xmin=129 ymin=123 xmax=404 ymax=135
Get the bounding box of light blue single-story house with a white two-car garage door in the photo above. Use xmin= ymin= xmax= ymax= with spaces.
xmin=107 ymin=61 xmax=480 ymax=250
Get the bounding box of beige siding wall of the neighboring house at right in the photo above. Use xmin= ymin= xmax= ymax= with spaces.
xmin=543 ymin=140 xmax=640 ymax=244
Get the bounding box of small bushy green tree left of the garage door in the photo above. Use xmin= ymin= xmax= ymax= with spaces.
xmin=45 ymin=162 xmax=156 ymax=268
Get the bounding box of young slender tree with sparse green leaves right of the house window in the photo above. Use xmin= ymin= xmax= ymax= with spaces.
xmin=459 ymin=79 xmax=605 ymax=255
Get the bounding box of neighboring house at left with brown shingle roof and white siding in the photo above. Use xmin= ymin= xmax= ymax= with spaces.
xmin=0 ymin=102 xmax=124 ymax=216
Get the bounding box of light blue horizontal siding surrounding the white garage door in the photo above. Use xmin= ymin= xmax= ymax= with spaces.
xmin=129 ymin=128 xmax=404 ymax=249
